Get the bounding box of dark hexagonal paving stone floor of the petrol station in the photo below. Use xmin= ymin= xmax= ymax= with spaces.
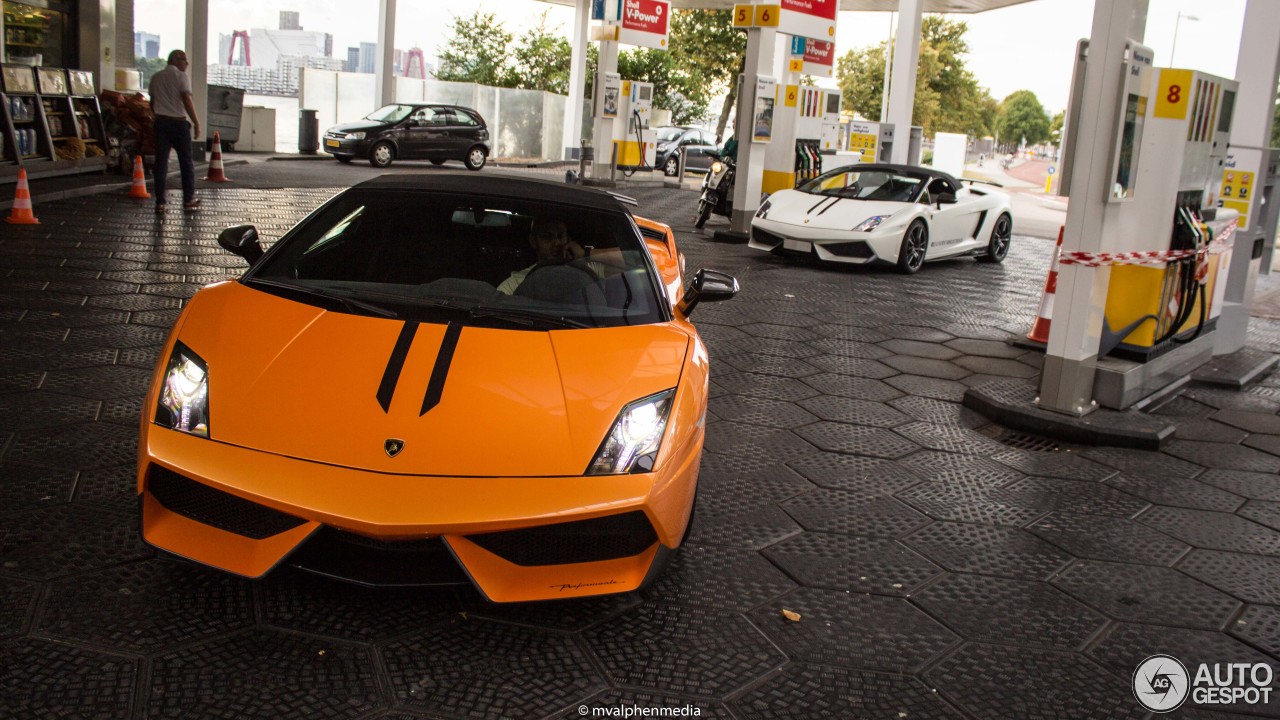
xmin=0 ymin=170 xmax=1280 ymax=720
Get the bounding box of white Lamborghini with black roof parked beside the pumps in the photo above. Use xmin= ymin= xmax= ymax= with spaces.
xmin=749 ymin=164 xmax=1014 ymax=273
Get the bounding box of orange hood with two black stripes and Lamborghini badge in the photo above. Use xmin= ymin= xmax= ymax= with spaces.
xmin=179 ymin=283 xmax=689 ymax=477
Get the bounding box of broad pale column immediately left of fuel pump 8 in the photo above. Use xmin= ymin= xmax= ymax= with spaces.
xmin=1041 ymin=0 xmax=1147 ymax=415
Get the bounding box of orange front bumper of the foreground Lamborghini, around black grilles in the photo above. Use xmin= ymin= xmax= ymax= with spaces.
xmin=138 ymin=425 xmax=703 ymax=602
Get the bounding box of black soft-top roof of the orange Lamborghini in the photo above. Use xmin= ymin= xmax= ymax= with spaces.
xmin=351 ymin=170 xmax=626 ymax=213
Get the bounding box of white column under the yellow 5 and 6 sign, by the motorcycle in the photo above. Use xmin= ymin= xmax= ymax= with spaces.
xmin=730 ymin=27 xmax=778 ymax=236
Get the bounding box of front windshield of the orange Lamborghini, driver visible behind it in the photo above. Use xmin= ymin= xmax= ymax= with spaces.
xmin=246 ymin=190 xmax=667 ymax=331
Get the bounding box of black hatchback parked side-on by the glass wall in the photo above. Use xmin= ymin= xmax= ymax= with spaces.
xmin=324 ymin=102 xmax=489 ymax=170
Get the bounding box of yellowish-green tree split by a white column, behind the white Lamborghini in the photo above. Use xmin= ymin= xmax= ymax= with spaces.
xmin=836 ymin=15 xmax=997 ymax=137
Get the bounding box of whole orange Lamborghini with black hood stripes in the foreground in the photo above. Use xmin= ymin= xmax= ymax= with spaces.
xmin=138 ymin=173 xmax=737 ymax=602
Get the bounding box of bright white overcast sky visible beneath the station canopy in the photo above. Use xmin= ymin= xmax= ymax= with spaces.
xmin=134 ymin=0 xmax=1245 ymax=113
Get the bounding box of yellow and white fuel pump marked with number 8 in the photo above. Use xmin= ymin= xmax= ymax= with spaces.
xmin=1100 ymin=68 xmax=1238 ymax=361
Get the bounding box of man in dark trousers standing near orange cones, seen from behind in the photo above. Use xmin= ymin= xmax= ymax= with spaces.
xmin=148 ymin=50 xmax=200 ymax=213
